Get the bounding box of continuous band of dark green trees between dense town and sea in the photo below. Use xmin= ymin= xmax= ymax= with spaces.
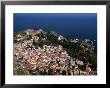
xmin=36 ymin=32 xmax=97 ymax=69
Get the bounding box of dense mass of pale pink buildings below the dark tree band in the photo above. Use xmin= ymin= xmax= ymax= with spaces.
xmin=14 ymin=30 xmax=96 ymax=75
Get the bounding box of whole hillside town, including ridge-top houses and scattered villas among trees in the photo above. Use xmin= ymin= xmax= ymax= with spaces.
xmin=13 ymin=29 xmax=97 ymax=75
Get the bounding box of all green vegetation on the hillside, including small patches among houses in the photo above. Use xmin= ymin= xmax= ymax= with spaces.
xmin=14 ymin=29 xmax=97 ymax=71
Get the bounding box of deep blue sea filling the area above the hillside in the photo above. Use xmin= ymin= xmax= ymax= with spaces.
xmin=13 ymin=13 xmax=97 ymax=51
